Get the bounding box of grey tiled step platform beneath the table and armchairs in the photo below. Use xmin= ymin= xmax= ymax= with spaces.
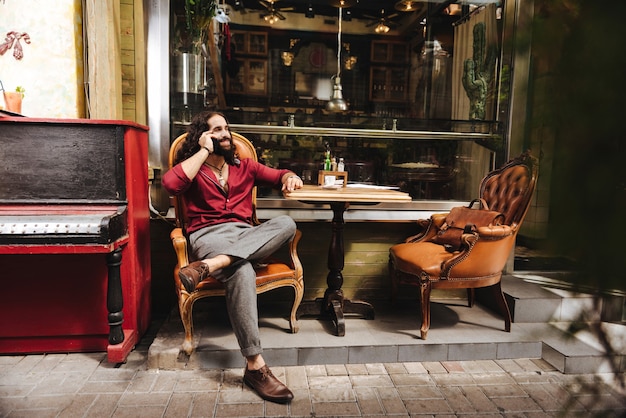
xmin=148 ymin=276 xmax=626 ymax=373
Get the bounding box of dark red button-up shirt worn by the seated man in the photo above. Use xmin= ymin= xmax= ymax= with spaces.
xmin=163 ymin=158 xmax=289 ymax=233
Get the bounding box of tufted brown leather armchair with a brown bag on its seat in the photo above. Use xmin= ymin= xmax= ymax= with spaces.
xmin=389 ymin=152 xmax=538 ymax=340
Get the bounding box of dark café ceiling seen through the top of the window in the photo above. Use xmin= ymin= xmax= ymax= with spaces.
xmin=226 ymin=0 xmax=454 ymax=23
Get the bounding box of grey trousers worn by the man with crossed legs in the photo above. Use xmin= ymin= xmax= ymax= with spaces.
xmin=189 ymin=215 xmax=296 ymax=357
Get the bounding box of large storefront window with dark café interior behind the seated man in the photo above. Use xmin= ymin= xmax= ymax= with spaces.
xmin=171 ymin=1 xmax=506 ymax=200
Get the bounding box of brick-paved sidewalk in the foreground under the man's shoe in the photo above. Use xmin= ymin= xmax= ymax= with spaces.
xmin=0 ymin=346 xmax=626 ymax=418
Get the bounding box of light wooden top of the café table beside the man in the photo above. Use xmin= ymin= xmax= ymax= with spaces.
xmin=284 ymin=184 xmax=412 ymax=203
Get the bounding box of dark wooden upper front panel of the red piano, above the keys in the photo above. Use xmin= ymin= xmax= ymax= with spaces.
xmin=0 ymin=118 xmax=127 ymax=205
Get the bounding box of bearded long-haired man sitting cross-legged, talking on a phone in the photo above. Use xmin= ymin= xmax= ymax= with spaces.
xmin=163 ymin=112 xmax=302 ymax=402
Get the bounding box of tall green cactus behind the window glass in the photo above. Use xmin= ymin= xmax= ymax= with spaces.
xmin=463 ymin=22 xmax=496 ymax=120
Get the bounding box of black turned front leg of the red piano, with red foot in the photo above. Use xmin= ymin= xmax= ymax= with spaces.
xmin=106 ymin=247 xmax=137 ymax=363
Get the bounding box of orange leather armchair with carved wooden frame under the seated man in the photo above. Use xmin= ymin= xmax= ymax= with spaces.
xmin=169 ymin=132 xmax=304 ymax=355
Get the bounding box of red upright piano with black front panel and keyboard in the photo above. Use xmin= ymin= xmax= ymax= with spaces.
xmin=0 ymin=117 xmax=150 ymax=363
